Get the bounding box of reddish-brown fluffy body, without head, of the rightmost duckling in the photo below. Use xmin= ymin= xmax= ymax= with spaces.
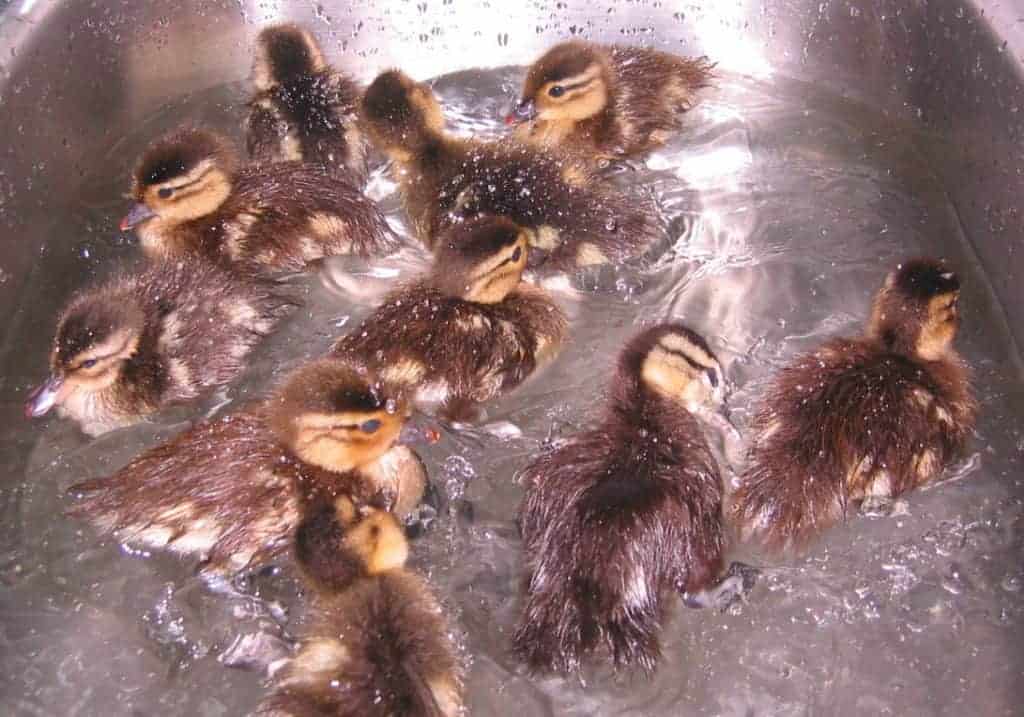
xmin=732 ymin=340 xmax=976 ymax=549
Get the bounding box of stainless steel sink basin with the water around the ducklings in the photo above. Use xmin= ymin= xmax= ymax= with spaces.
xmin=0 ymin=0 xmax=1024 ymax=717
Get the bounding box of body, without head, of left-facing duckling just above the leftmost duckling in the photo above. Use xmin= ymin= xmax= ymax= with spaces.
xmin=219 ymin=162 xmax=398 ymax=270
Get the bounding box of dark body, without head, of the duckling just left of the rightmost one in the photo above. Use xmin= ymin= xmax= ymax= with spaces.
xmin=513 ymin=419 xmax=724 ymax=672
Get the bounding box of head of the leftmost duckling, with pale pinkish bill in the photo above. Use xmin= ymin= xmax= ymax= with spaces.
xmin=25 ymin=294 xmax=145 ymax=418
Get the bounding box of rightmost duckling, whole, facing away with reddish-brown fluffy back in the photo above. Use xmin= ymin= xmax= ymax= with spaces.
xmin=730 ymin=259 xmax=978 ymax=550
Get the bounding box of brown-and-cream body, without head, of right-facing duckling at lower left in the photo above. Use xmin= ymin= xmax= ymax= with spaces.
xmin=68 ymin=412 xmax=299 ymax=571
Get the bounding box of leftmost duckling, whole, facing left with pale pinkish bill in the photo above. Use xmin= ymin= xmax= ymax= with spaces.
xmin=25 ymin=257 xmax=296 ymax=436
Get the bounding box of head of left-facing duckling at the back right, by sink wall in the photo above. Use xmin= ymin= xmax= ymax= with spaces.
xmin=505 ymin=42 xmax=611 ymax=124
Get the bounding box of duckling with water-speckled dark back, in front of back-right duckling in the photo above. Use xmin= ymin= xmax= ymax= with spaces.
xmin=362 ymin=70 xmax=664 ymax=270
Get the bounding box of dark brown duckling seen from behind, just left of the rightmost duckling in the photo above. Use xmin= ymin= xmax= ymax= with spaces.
xmin=513 ymin=323 xmax=724 ymax=673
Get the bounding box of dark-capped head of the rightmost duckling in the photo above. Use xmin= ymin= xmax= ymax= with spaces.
xmin=867 ymin=259 xmax=961 ymax=361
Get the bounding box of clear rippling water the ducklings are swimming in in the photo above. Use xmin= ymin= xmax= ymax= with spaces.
xmin=0 ymin=64 xmax=1024 ymax=717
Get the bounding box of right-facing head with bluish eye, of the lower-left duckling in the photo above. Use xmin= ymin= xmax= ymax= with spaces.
xmin=269 ymin=359 xmax=409 ymax=473
